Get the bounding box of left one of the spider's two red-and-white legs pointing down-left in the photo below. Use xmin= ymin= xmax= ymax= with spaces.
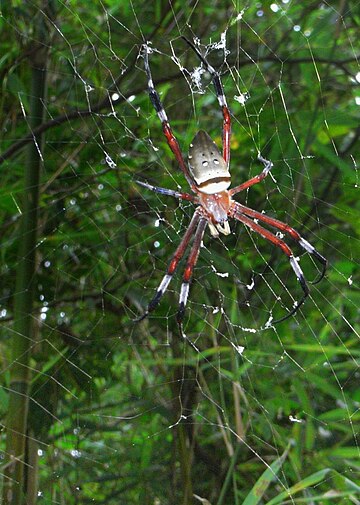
xmin=136 ymin=211 xmax=200 ymax=322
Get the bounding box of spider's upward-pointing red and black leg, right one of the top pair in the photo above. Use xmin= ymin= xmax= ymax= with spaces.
xmin=181 ymin=37 xmax=231 ymax=166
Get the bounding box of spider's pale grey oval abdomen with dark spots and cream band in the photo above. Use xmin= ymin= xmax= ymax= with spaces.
xmin=189 ymin=130 xmax=230 ymax=195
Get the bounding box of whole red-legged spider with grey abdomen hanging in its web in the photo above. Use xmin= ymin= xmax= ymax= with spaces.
xmin=136 ymin=37 xmax=327 ymax=331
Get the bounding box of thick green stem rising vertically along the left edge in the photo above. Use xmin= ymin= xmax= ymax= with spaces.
xmin=3 ymin=42 xmax=46 ymax=505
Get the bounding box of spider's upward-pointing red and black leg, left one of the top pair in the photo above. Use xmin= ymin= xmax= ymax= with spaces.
xmin=143 ymin=44 xmax=196 ymax=192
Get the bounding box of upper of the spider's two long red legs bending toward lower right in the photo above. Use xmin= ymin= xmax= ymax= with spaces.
xmin=237 ymin=203 xmax=328 ymax=284
